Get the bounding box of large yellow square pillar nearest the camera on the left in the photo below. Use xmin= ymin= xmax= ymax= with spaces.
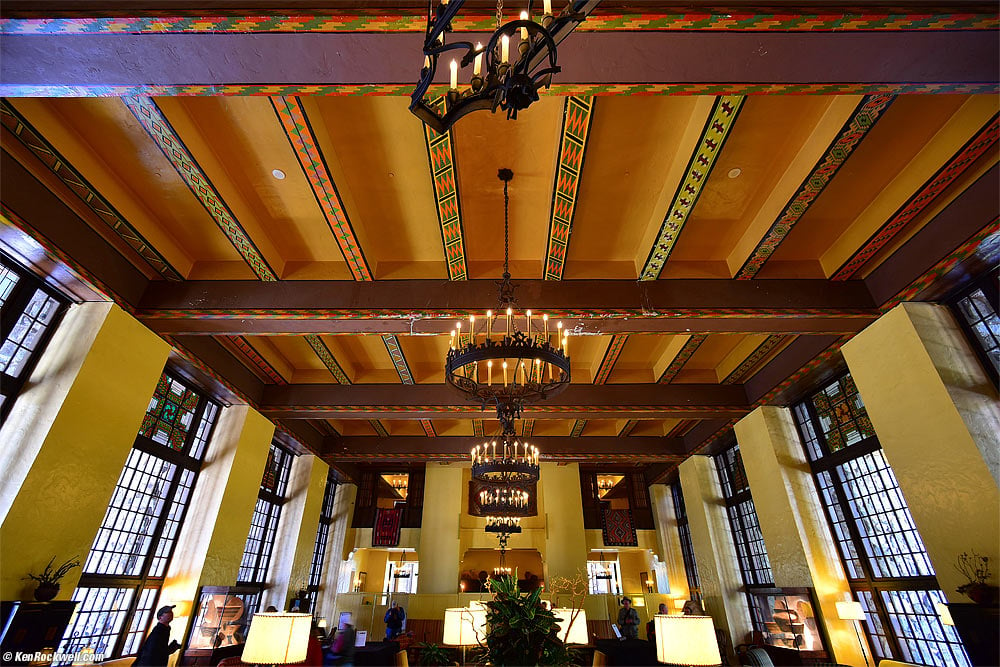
xmin=0 ymin=303 xmax=170 ymax=600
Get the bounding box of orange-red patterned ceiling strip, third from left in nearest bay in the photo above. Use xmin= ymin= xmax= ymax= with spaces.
xmin=269 ymin=96 xmax=372 ymax=280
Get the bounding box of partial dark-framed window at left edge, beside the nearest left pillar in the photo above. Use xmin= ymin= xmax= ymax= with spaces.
xmin=0 ymin=253 xmax=69 ymax=421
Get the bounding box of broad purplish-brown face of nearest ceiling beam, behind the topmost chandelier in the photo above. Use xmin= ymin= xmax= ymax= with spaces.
xmin=0 ymin=30 xmax=1000 ymax=96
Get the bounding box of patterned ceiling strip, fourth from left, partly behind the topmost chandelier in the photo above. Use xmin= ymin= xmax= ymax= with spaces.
xmin=424 ymin=96 xmax=469 ymax=280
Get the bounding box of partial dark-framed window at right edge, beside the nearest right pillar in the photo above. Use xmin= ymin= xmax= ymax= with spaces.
xmin=947 ymin=270 xmax=1000 ymax=384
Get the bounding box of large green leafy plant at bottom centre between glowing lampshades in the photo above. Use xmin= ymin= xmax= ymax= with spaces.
xmin=486 ymin=576 xmax=571 ymax=665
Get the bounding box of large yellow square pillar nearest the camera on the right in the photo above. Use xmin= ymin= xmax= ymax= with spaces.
xmin=842 ymin=303 xmax=1000 ymax=602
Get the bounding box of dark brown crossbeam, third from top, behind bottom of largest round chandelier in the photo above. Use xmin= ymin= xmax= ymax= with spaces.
xmin=259 ymin=384 xmax=750 ymax=418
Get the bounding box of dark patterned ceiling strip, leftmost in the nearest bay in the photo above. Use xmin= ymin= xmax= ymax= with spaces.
xmin=0 ymin=100 xmax=184 ymax=281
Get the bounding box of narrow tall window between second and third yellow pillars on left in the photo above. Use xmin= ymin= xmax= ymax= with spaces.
xmin=236 ymin=442 xmax=292 ymax=618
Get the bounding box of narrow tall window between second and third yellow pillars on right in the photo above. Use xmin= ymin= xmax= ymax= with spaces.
xmin=715 ymin=442 xmax=774 ymax=631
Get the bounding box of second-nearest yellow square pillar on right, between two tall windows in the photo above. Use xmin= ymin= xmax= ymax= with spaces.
xmin=734 ymin=406 xmax=864 ymax=665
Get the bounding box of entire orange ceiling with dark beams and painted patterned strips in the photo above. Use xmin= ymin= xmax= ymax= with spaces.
xmin=0 ymin=2 xmax=998 ymax=477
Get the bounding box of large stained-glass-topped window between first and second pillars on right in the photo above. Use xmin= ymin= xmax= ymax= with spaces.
xmin=794 ymin=375 xmax=969 ymax=665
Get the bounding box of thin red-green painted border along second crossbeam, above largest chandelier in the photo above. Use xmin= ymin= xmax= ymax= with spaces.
xmin=139 ymin=308 xmax=877 ymax=322
